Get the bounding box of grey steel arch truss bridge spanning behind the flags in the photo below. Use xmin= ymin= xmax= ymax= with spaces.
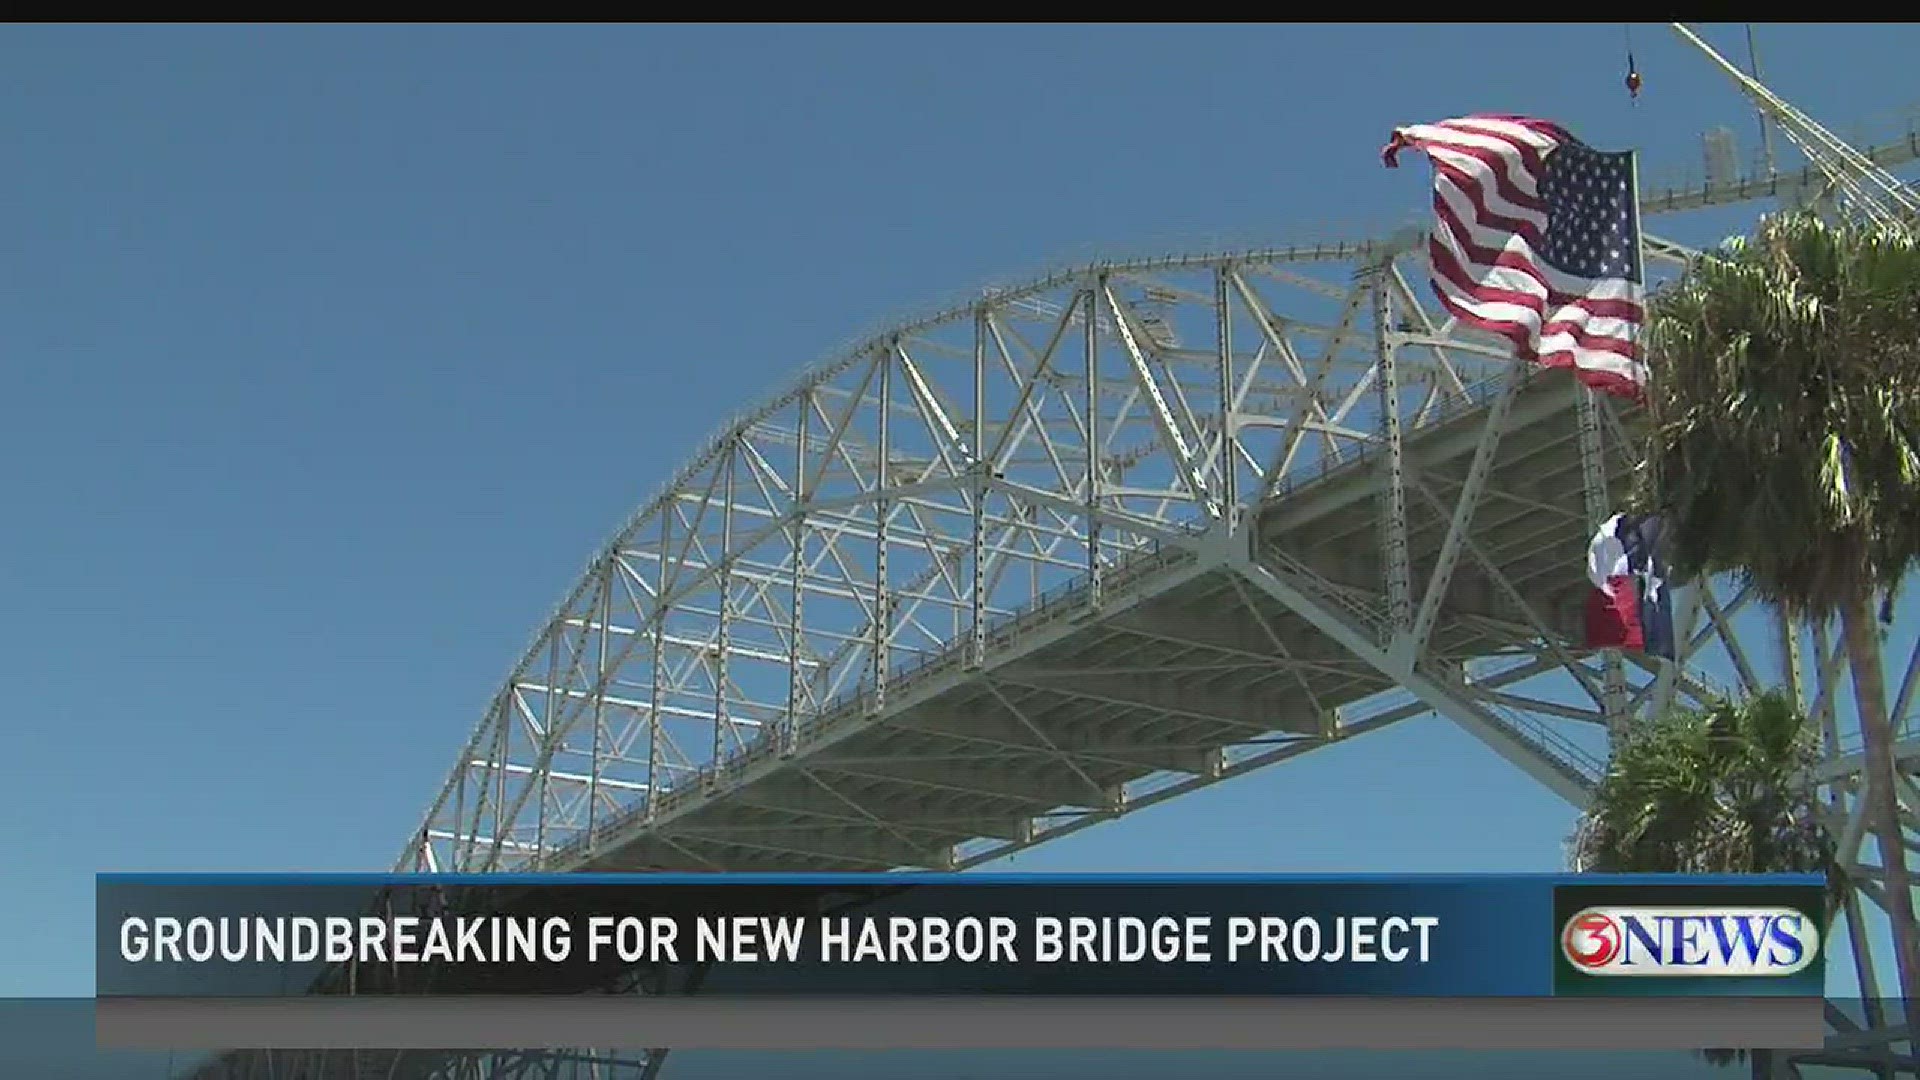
xmin=202 ymin=115 xmax=1920 ymax=1076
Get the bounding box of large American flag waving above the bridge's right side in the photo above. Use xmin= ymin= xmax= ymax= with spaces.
xmin=1382 ymin=115 xmax=1647 ymax=398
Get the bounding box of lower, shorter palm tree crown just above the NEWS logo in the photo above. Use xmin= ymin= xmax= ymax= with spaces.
xmin=1571 ymin=690 xmax=1845 ymax=1078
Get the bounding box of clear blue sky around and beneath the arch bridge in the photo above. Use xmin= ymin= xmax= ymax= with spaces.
xmin=0 ymin=25 xmax=1920 ymax=995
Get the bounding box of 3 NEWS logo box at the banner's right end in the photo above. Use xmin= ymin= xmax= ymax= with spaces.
xmin=1553 ymin=886 xmax=1826 ymax=995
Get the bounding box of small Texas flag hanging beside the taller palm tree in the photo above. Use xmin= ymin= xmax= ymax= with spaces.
xmin=1586 ymin=513 xmax=1674 ymax=659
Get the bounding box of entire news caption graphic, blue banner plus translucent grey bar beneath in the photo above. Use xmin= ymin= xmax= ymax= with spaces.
xmin=96 ymin=874 xmax=1828 ymax=1049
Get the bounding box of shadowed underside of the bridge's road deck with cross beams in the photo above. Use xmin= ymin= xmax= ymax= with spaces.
xmin=543 ymin=373 xmax=1617 ymax=871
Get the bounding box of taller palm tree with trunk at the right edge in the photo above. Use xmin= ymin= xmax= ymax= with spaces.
xmin=1642 ymin=213 xmax=1920 ymax=1030
